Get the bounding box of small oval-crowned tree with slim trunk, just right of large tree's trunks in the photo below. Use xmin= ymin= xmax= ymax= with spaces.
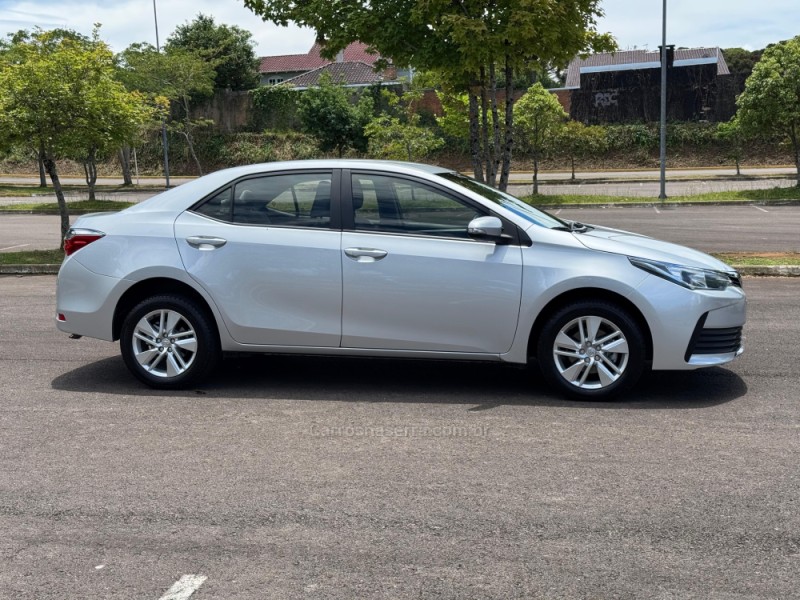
xmin=514 ymin=83 xmax=568 ymax=194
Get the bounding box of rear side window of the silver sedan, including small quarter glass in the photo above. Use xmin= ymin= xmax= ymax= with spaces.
xmin=195 ymin=172 xmax=331 ymax=227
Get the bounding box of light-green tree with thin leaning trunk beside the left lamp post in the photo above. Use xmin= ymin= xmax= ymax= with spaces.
xmin=119 ymin=44 xmax=216 ymax=175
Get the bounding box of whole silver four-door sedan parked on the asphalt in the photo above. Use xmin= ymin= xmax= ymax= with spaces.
xmin=56 ymin=160 xmax=746 ymax=399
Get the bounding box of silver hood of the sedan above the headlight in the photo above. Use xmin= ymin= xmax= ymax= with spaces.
xmin=573 ymin=226 xmax=733 ymax=271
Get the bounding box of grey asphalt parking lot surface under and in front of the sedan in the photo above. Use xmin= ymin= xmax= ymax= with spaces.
xmin=0 ymin=277 xmax=800 ymax=600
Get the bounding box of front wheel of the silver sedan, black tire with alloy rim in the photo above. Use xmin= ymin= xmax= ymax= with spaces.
xmin=536 ymin=301 xmax=646 ymax=400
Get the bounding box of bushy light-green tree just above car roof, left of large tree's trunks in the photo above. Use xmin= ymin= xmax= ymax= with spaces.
xmin=364 ymin=90 xmax=444 ymax=162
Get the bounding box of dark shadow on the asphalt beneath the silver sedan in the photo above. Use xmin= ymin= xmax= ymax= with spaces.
xmin=52 ymin=355 xmax=747 ymax=411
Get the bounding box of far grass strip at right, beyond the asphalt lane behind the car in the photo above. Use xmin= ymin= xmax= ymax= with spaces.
xmin=522 ymin=186 xmax=800 ymax=206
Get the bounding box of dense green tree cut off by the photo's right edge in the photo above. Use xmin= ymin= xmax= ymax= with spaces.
xmin=736 ymin=36 xmax=800 ymax=187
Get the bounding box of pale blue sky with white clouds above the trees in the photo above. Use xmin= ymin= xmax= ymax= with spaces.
xmin=0 ymin=0 xmax=800 ymax=56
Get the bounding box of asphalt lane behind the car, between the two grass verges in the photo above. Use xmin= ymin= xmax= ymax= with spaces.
xmin=0 ymin=206 xmax=800 ymax=252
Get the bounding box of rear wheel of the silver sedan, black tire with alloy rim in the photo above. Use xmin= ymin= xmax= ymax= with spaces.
xmin=120 ymin=295 xmax=221 ymax=389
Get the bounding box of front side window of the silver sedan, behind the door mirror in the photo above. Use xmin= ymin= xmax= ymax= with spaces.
xmin=351 ymin=173 xmax=487 ymax=238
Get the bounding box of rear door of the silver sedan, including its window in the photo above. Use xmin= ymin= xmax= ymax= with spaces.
xmin=175 ymin=170 xmax=342 ymax=347
